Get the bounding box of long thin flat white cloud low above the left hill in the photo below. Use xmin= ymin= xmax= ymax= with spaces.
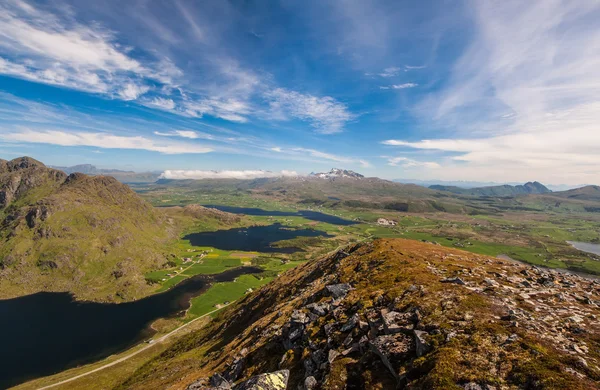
xmin=0 ymin=129 xmax=212 ymax=154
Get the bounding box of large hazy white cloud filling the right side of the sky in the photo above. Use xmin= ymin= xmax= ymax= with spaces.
xmin=400 ymin=0 xmax=600 ymax=184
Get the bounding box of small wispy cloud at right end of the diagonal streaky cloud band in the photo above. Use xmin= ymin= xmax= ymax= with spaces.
xmin=265 ymin=88 xmax=356 ymax=134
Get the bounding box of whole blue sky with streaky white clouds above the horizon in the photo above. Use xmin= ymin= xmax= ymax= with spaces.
xmin=0 ymin=0 xmax=600 ymax=184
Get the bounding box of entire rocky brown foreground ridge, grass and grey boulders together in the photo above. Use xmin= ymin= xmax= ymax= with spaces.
xmin=119 ymin=239 xmax=600 ymax=390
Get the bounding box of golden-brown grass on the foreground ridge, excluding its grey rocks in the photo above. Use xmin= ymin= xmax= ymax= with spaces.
xmin=119 ymin=240 xmax=598 ymax=390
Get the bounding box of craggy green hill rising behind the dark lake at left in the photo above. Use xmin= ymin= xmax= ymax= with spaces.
xmin=0 ymin=157 xmax=175 ymax=301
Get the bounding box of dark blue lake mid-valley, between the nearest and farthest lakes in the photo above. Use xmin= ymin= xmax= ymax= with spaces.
xmin=183 ymin=223 xmax=332 ymax=253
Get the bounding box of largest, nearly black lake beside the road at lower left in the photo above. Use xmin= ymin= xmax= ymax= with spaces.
xmin=0 ymin=267 xmax=262 ymax=389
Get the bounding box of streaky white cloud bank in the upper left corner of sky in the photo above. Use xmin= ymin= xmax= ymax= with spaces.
xmin=0 ymin=0 xmax=181 ymax=100
